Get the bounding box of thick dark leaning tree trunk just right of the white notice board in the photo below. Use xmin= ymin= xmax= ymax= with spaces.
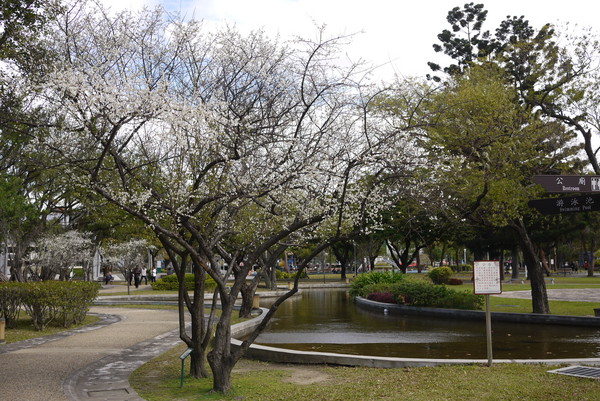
xmin=512 ymin=219 xmax=550 ymax=314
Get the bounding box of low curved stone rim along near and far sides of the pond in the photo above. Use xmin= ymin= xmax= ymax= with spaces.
xmin=231 ymin=298 xmax=600 ymax=368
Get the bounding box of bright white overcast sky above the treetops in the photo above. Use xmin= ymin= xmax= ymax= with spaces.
xmin=102 ymin=0 xmax=600 ymax=79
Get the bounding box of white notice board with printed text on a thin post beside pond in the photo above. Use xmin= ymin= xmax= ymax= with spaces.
xmin=473 ymin=260 xmax=502 ymax=366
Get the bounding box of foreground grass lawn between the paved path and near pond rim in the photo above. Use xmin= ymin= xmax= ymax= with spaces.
xmin=130 ymin=340 xmax=600 ymax=401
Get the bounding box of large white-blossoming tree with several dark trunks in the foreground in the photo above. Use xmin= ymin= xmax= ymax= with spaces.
xmin=32 ymin=1 xmax=418 ymax=392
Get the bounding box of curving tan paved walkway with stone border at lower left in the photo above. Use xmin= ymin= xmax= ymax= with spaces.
xmin=0 ymin=307 xmax=179 ymax=401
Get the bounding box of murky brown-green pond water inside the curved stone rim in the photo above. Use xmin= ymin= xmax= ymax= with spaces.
xmin=256 ymin=289 xmax=600 ymax=359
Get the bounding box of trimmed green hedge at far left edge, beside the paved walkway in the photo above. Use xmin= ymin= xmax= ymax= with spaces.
xmin=0 ymin=281 xmax=100 ymax=330
